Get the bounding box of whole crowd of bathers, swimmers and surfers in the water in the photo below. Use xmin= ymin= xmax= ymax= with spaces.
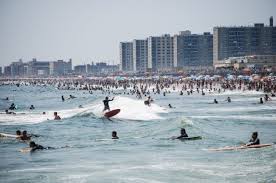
xmin=0 ymin=75 xmax=276 ymax=151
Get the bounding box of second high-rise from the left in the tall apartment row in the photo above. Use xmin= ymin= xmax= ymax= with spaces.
xmin=133 ymin=39 xmax=148 ymax=72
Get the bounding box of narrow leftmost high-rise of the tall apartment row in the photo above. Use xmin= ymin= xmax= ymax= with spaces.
xmin=120 ymin=42 xmax=134 ymax=71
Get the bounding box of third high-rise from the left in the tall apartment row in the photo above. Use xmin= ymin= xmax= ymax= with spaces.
xmin=148 ymin=34 xmax=176 ymax=71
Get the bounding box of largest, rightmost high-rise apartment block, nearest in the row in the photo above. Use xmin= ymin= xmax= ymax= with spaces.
xmin=213 ymin=17 xmax=276 ymax=64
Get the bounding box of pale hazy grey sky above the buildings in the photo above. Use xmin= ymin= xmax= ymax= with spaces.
xmin=0 ymin=0 xmax=276 ymax=66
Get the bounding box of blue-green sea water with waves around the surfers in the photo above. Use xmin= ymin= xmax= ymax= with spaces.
xmin=0 ymin=86 xmax=276 ymax=183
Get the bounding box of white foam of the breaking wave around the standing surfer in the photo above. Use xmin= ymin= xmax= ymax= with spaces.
xmin=0 ymin=97 xmax=167 ymax=125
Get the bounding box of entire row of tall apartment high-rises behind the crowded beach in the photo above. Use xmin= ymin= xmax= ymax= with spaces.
xmin=120 ymin=17 xmax=276 ymax=72
